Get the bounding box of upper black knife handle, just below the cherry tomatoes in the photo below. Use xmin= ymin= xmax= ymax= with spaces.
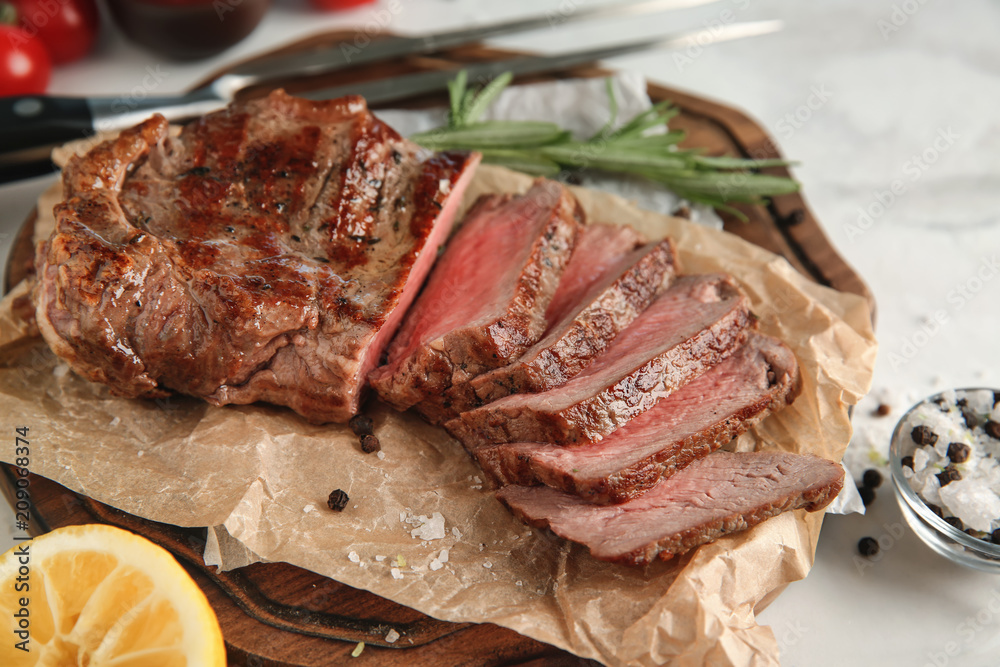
xmin=0 ymin=95 xmax=94 ymax=153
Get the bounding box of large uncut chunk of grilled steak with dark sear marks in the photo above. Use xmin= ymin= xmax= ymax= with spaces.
xmin=35 ymin=91 xmax=478 ymax=422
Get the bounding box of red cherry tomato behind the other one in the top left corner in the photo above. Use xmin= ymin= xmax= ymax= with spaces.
xmin=8 ymin=0 xmax=100 ymax=65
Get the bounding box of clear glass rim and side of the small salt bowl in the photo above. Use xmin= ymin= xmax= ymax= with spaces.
xmin=889 ymin=387 xmax=1000 ymax=574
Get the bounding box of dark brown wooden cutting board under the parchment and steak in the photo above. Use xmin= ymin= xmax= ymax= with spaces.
xmin=0 ymin=33 xmax=875 ymax=667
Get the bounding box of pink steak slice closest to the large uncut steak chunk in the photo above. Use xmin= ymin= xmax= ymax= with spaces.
xmin=371 ymin=179 xmax=583 ymax=422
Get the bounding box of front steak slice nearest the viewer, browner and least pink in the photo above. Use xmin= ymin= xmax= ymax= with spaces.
xmin=497 ymin=452 xmax=844 ymax=565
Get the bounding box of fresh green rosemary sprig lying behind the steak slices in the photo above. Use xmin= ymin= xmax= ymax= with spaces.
xmin=411 ymin=70 xmax=799 ymax=219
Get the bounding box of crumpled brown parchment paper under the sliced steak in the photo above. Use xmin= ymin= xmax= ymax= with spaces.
xmin=0 ymin=77 xmax=876 ymax=665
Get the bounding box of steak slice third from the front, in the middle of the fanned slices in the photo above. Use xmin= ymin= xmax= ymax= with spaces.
xmin=445 ymin=275 xmax=753 ymax=447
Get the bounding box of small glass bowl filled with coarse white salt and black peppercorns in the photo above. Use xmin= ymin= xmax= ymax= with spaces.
xmin=889 ymin=388 xmax=1000 ymax=573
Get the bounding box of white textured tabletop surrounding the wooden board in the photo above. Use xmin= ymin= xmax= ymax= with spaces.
xmin=0 ymin=0 xmax=1000 ymax=667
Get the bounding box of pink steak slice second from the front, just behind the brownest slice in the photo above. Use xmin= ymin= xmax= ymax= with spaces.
xmin=473 ymin=334 xmax=801 ymax=504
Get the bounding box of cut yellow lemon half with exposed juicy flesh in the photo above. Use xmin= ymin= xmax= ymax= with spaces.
xmin=0 ymin=525 xmax=226 ymax=667
